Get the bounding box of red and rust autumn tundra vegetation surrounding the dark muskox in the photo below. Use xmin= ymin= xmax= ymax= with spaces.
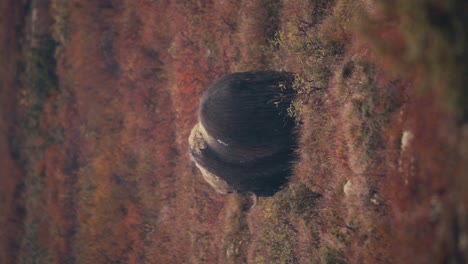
xmin=0 ymin=0 xmax=468 ymax=263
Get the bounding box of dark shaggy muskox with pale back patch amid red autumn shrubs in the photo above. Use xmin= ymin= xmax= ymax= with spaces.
xmin=189 ymin=72 xmax=296 ymax=196
